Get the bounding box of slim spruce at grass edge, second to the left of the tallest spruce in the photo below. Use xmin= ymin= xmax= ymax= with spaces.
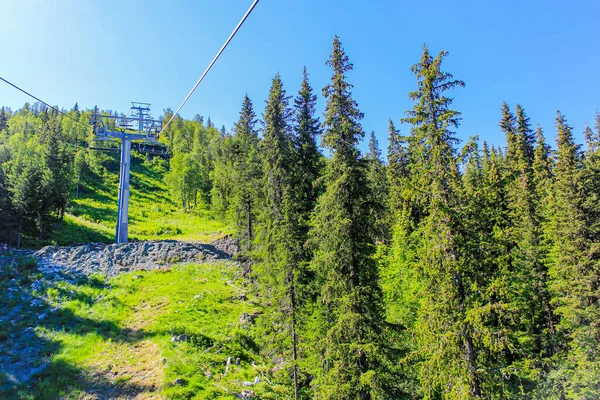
xmin=254 ymin=74 xmax=303 ymax=399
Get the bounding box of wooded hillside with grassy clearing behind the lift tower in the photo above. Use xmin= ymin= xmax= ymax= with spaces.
xmin=0 ymin=103 xmax=231 ymax=247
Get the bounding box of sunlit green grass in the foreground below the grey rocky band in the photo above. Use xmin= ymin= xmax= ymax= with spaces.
xmin=0 ymin=261 xmax=270 ymax=399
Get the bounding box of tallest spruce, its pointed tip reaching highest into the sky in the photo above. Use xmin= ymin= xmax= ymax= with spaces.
xmin=311 ymin=36 xmax=393 ymax=399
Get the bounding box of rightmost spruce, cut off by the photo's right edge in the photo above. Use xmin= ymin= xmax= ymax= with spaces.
xmin=546 ymin=112 xmax=600 ymax=399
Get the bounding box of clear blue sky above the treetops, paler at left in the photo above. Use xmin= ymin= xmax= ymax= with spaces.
xmin=0 ymin=0 xmax=600 ymax=152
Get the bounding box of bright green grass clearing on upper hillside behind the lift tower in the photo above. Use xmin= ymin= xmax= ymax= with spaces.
xmin=49 ymin=156 xmax=232 ymax=247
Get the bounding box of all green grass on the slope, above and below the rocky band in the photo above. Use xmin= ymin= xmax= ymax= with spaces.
xmin=0 ymin=158 xmax=276 ymax=399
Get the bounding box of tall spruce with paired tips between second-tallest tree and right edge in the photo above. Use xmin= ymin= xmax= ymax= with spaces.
xmin=495 ymin=104 xmax=554 ymax=393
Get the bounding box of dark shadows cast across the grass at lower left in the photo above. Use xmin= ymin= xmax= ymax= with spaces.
xmin=0 ymin=265 xmax=156 ymax=399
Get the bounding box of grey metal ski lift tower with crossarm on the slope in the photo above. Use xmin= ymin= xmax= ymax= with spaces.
xmin=90 ymin=102 xmax=162 ymax=243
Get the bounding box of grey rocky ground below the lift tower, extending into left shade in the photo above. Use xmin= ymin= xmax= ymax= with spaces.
xmin=0 ymin=237 xmax=244 ymax=398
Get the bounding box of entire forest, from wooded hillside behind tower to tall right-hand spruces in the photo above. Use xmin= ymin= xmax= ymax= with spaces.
xmin=0 ymin=37 xmax=600 ymax=399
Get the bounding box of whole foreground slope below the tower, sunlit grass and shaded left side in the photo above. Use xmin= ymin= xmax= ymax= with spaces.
xmin=0 ymin=242 xmax=269 ymax=399
